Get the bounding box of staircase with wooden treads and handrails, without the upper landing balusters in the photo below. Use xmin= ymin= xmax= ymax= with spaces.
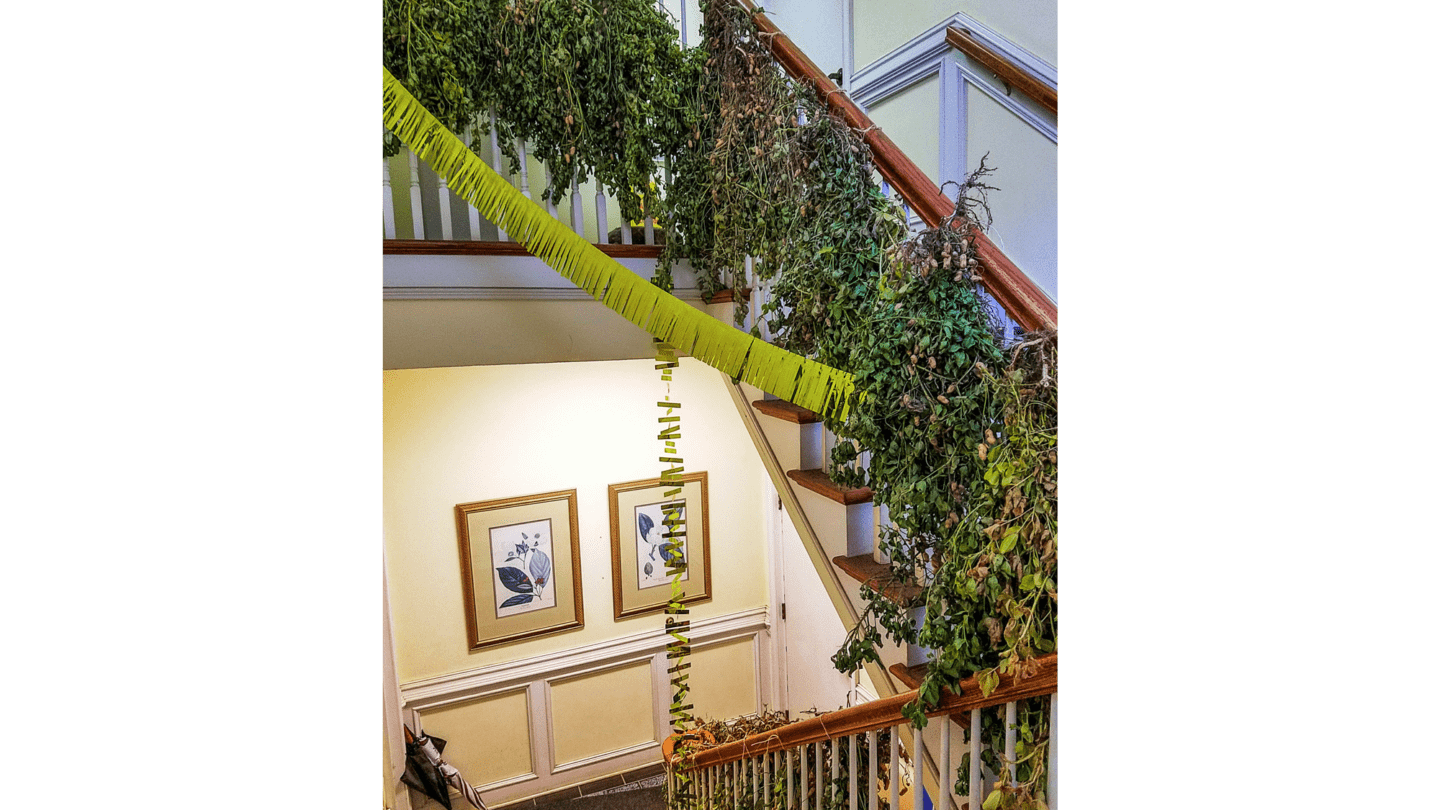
xmin=671 ymin=0 xmax=1060 ymax=810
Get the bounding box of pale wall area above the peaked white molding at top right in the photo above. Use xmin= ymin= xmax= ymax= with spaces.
xmin=855 ymin=0 xmax=1060 ymax=69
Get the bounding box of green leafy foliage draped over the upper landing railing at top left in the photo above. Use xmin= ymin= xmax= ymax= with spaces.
xmin=382 ymin=0 xmax=703 ymax=221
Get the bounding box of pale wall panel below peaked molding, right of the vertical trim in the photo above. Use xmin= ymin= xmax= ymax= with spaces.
xmin=965 ymin=86 xmax=1060 ymax=301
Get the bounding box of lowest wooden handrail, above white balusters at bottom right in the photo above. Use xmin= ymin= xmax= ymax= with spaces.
xmin=691 ymin=653 xmax=1060 ymax=768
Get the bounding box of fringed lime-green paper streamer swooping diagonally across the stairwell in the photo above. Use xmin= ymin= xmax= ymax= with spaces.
xmin=380 ymin=66 xmax=855 ymax=421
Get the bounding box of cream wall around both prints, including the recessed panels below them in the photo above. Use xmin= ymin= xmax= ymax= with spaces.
xmin=382 ymin=357 xmax=769 ymax=800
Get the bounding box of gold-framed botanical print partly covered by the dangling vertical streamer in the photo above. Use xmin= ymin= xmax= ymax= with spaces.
xmin=609 ymin=473 xmax=710 ymax=618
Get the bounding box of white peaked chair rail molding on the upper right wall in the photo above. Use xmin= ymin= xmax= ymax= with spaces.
xmin=850 ymin=12 xmax=1060 ymax=142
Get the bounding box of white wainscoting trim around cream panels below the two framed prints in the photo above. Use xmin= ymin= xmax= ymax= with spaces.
xmin=400 ymin=607 xmax=775 ymax=806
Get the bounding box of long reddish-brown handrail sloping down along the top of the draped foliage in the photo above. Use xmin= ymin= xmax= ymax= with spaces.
xmin=734 ymin=0 xmax=1060 ymax=330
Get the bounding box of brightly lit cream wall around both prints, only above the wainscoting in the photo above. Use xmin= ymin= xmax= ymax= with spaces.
xmin=383 ymin=357 xmax=768 ymax=683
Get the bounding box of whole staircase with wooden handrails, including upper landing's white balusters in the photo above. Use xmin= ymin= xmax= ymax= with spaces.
xmin=382 ymin=0 xmax=1058 ymax=810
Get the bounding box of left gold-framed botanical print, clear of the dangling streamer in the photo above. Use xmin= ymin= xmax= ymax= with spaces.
xmin=455 ymin=490 xmax=585 ymax=650
